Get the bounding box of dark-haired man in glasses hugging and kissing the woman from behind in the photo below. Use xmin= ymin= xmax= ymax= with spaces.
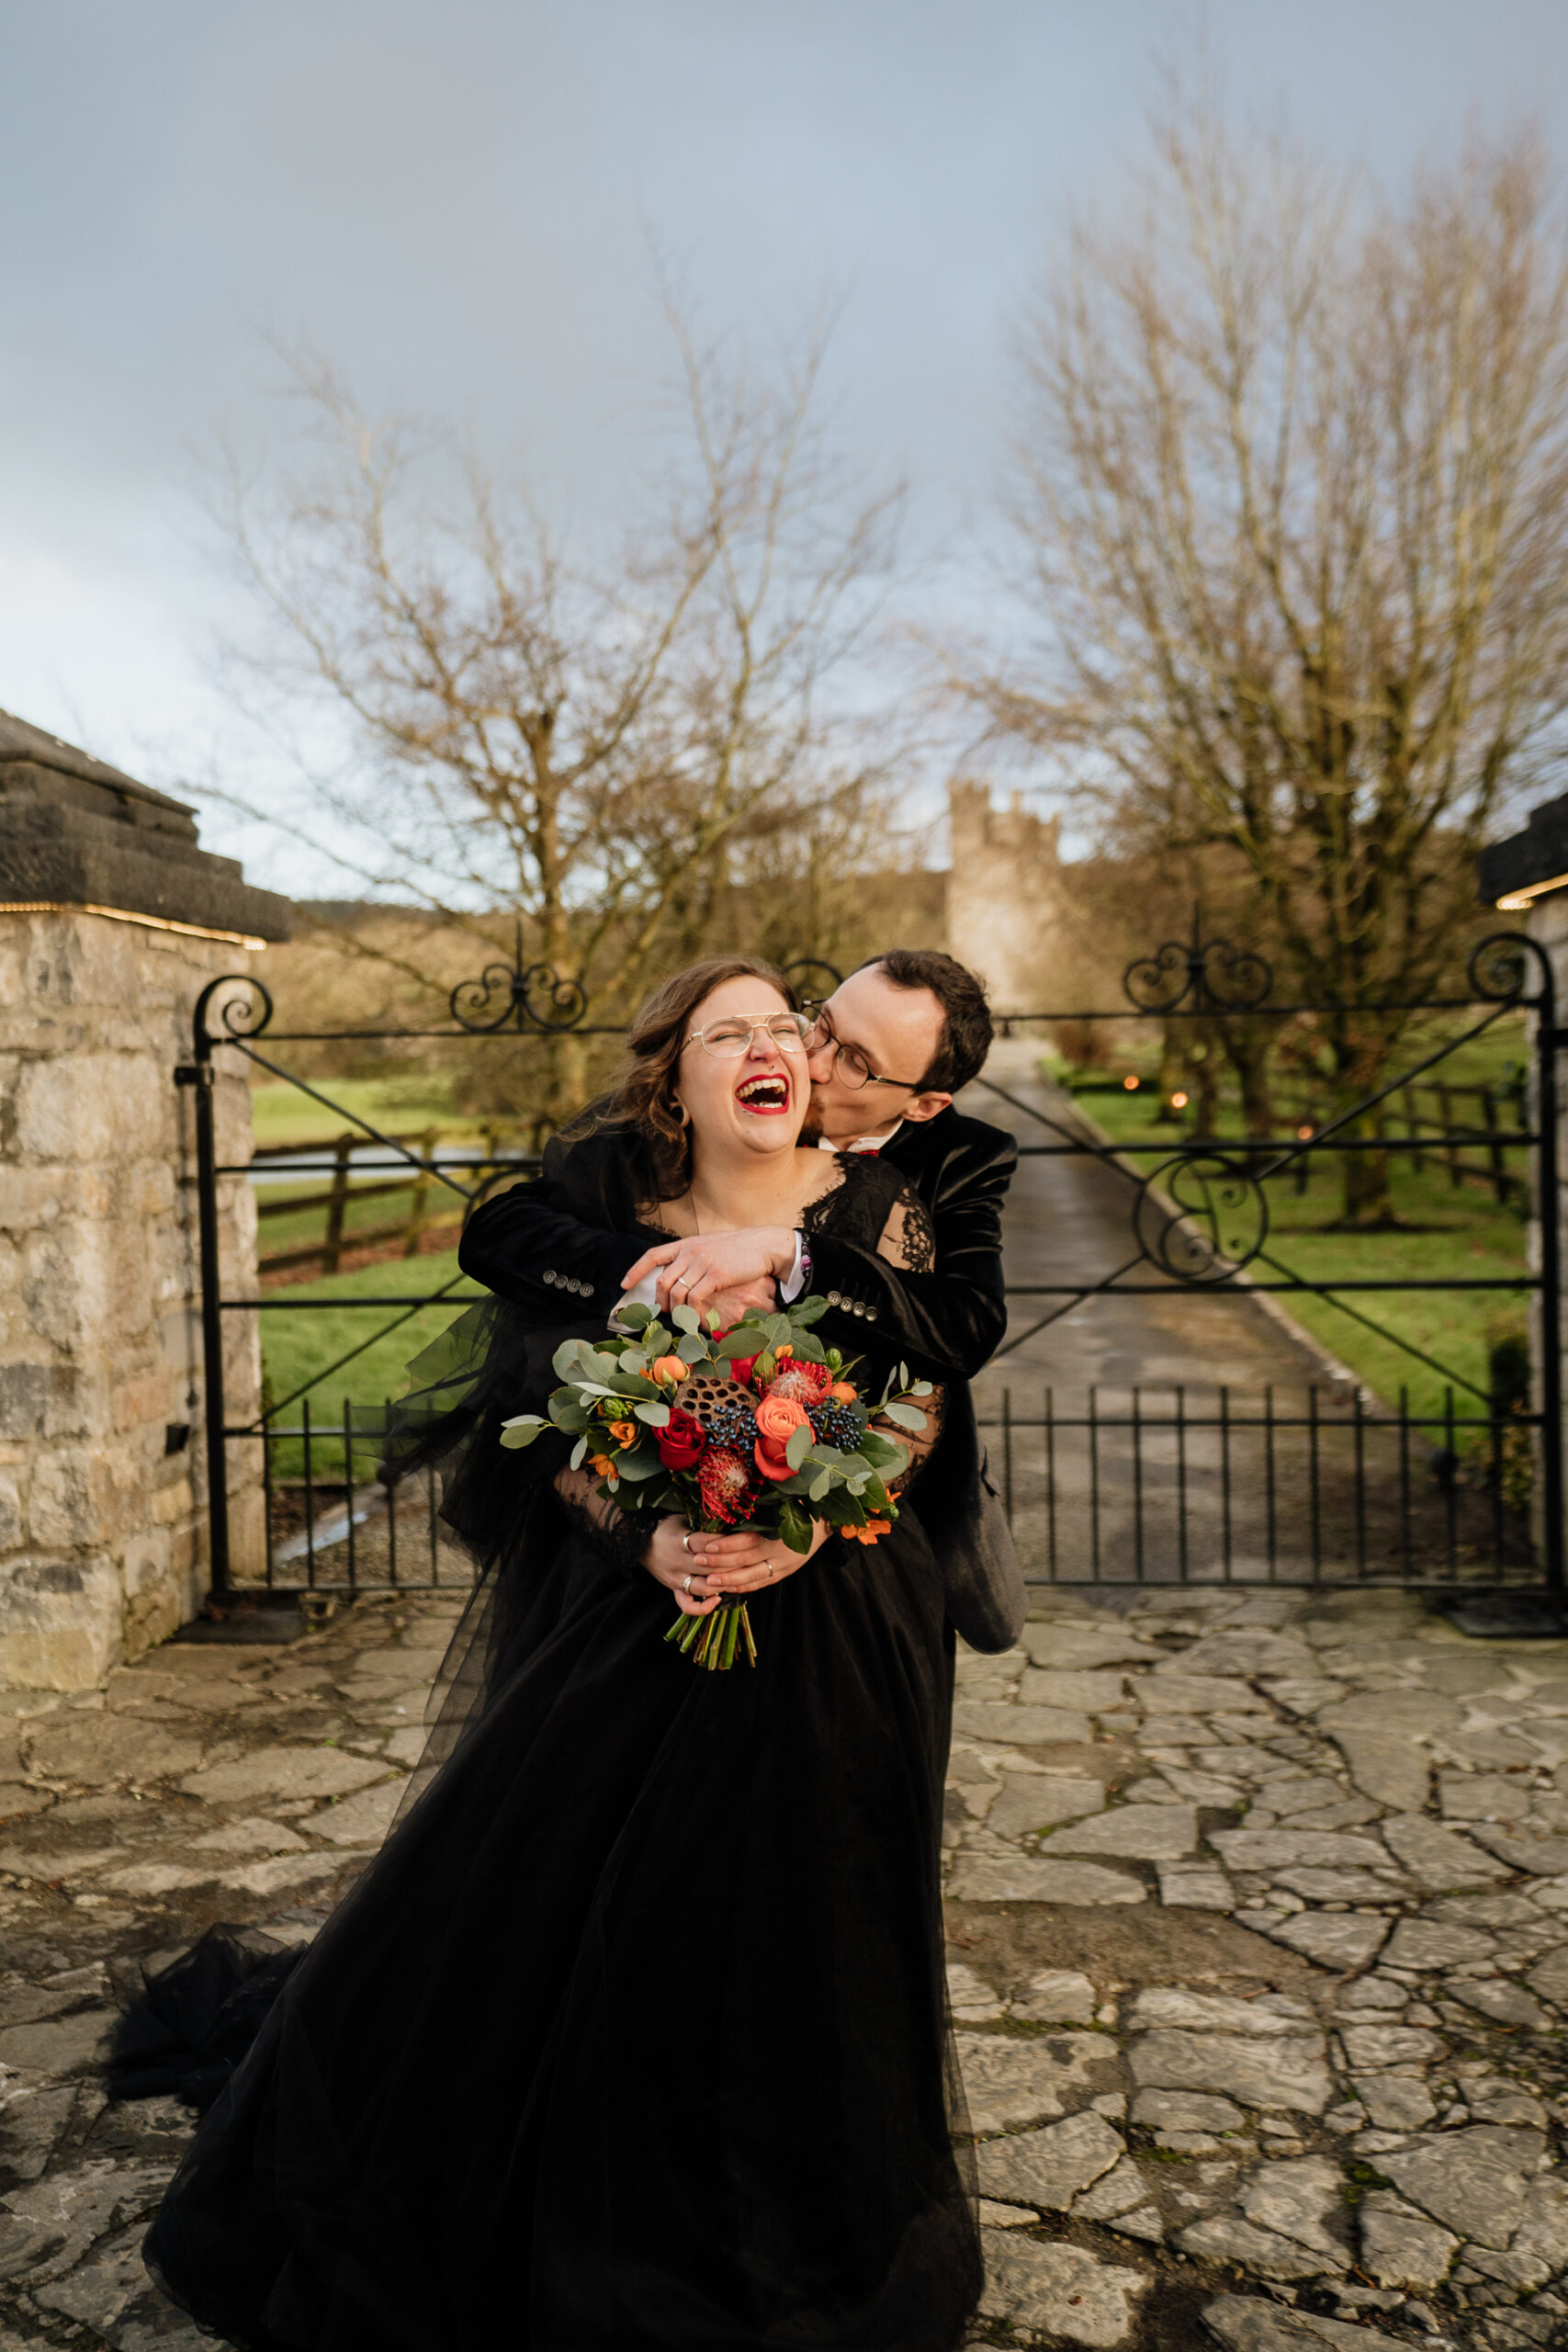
xmin=458 ymin=948 xmax=1022 ymax=1649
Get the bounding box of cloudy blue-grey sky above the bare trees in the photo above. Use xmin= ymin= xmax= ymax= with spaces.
xmin=0 ymin=0 xmax=1568 ymax=894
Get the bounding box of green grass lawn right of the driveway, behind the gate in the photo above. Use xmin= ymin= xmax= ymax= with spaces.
xmin=1046 ymin=1039 xmax=1530 ymax=1414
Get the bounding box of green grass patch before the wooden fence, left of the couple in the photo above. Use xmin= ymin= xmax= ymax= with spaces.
xmin=259 ymin=1249 xmax=487 ymax=1479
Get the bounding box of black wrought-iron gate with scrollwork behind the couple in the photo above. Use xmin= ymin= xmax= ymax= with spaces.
xmin=176 ymin=920 xmax=1568 ymax=1601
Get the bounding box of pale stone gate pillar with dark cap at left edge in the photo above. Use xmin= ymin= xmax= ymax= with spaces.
xmin=0 ymin=713 xmax=289 ymax=1691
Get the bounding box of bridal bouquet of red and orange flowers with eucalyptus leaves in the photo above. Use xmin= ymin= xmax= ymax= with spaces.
xmin=501 ymin=1298 xmax=931 ymax=1670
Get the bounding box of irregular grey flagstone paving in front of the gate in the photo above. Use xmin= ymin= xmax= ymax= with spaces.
xmin=0 ymin=1585 xmax=1568 ymax=2352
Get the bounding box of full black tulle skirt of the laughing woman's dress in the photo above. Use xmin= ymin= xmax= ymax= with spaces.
xmin=146 ymin=1510 xmax=980 ymax=2352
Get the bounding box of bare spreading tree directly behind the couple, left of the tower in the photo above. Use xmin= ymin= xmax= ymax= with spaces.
xmin=204 ymin=308 xmax=900 ymax=1108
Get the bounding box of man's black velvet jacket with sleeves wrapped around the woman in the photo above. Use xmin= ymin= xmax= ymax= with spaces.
xmin=458 ymin=1110 xmax=1018 ymax=1378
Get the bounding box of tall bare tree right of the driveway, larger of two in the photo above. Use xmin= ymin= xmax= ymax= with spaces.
xmin=954 ymin=87 xmax=1568 ymax=1223
